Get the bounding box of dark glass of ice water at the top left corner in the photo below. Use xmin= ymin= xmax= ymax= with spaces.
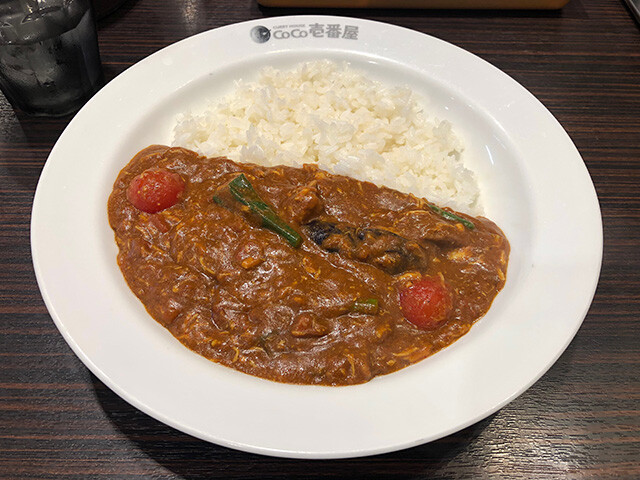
xmin=0 ymin=0 xmax=103 ymax=115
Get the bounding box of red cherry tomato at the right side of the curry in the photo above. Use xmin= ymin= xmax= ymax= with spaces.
xmin=400 ymin=277 xmax=451 ymax=330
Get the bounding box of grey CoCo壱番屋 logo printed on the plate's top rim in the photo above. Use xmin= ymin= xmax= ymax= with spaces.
xmin=250 ymin=23 xmax=359 ymax=43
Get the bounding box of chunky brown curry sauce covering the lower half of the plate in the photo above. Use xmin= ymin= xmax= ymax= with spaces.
xmin=108 ymin=146 xmax=509 ymax=385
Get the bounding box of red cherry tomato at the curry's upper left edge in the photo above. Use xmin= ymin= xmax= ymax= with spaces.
xmin=127 ymin=169 xmax=184 ymax=213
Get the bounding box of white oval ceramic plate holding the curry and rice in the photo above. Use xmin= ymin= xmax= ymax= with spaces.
xmin=31 ymin=16 xmax=602 ymax=458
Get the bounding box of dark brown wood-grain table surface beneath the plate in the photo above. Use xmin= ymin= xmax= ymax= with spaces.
xmin=0 ymin=0 xmax=640 ymax=479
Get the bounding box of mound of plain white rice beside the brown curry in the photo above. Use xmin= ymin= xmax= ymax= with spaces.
xmin=173 ymin=60 xmax=482 ymax=214
